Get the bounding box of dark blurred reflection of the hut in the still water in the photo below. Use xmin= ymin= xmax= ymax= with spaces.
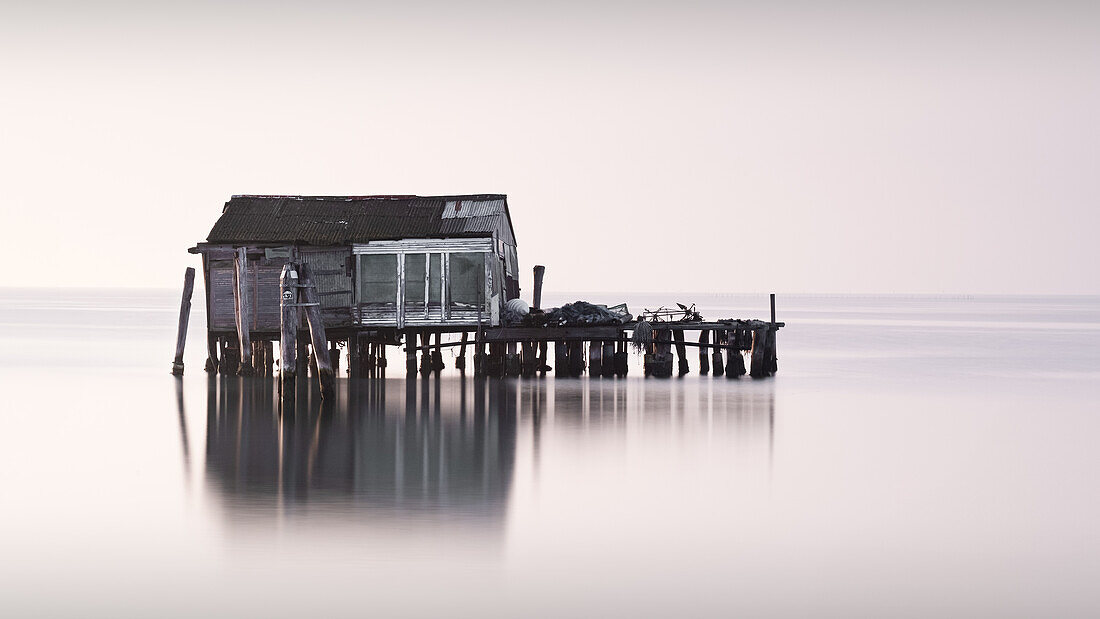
xmin=206 ymin=376 xmax=516 ymax=522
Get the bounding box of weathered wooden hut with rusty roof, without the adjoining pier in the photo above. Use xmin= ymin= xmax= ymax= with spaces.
xmin=189 ymin=194 xmax=519 ymax=384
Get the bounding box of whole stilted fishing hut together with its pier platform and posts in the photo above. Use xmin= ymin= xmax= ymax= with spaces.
xmin=173 ymin=194 xmax=784 ymax=395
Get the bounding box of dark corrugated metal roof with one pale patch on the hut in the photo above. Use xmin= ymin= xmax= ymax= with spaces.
xmin=207 ymin=194 xmax=515 ymax=245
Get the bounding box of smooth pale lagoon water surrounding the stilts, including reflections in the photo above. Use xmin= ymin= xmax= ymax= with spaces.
xmin=0 ymin=289 xmax=1100 ymax=619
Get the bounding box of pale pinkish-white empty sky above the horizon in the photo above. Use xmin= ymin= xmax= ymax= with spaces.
xmin=0 ymin=0 xmax=1100 ymax=296
